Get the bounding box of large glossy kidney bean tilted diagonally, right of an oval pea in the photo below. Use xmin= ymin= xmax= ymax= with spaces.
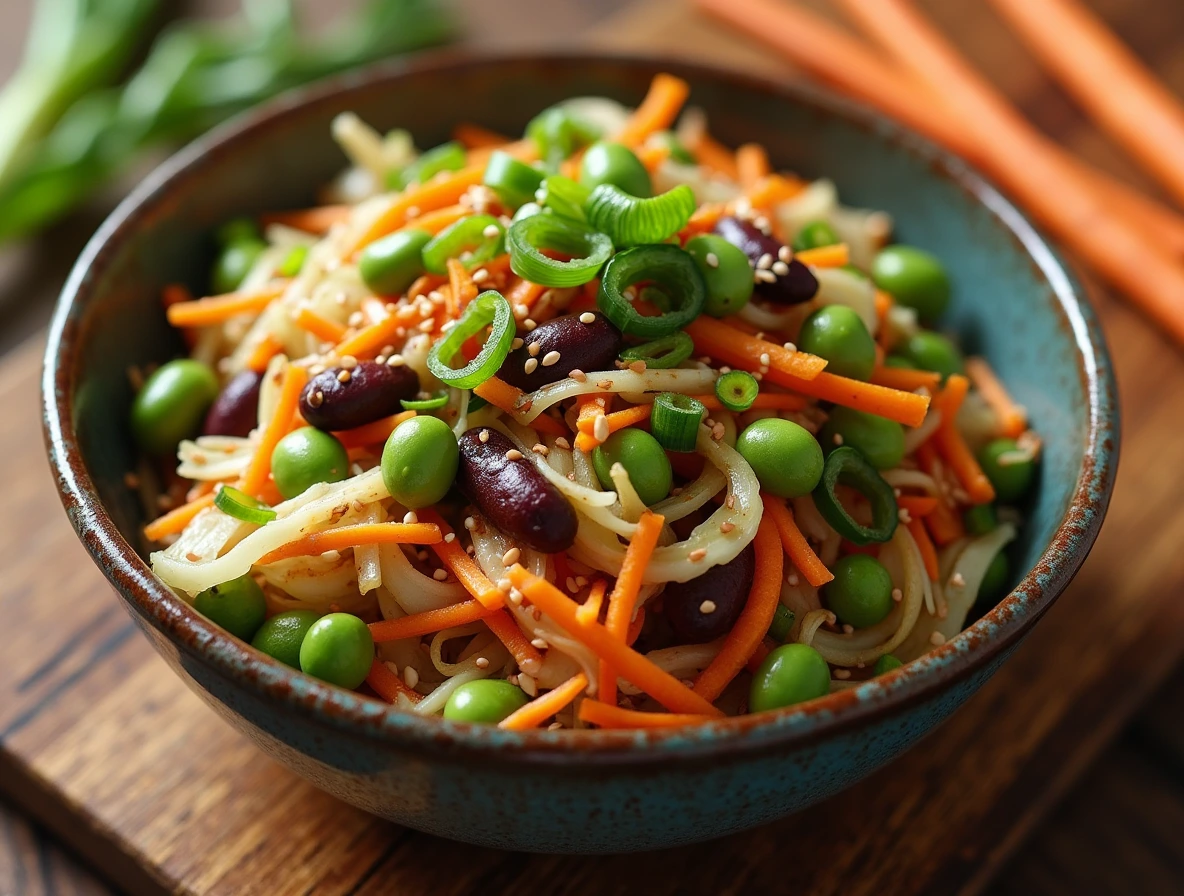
xmin=456 ymin=427 xmax=579 ymax=554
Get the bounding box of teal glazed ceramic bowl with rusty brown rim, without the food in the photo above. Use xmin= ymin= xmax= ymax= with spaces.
xmin=44 ymin=54 xmax=1118 ymax=852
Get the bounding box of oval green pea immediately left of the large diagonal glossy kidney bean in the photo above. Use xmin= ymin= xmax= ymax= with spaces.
xmin=382 ymin=414 xmax=461 ymax=509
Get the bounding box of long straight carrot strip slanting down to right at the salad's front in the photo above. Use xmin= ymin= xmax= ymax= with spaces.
xmin=509 ymin=563 xmax=723 ymax=717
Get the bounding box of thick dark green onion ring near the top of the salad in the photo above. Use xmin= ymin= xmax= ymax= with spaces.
xmin=601 ymin=245 xmax=707 ymax=340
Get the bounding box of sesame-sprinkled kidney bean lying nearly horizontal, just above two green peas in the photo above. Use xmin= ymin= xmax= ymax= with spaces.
xmin=300 ymin=361 xmax=419 ymax=432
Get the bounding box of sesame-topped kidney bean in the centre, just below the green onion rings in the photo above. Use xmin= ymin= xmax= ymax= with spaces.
xmin=497 ymin=311 xmax=624 ymax=392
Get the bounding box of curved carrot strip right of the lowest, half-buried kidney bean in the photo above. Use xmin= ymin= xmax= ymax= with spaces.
xmin=691 ymin=517 xmax=785 ymax=701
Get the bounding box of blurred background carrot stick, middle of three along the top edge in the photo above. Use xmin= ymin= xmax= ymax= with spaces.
xmin=841 ymin=0 xmax=1184 ymax=342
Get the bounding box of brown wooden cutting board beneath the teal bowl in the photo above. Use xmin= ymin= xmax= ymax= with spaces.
xmin=0 ymin=2 xmax=1184 ymax=896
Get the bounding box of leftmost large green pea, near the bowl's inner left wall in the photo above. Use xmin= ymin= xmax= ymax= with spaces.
xmin=131 ymin=357 xmax=218 ymax=455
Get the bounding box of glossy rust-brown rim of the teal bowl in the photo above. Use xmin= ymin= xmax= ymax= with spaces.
xmin=41 ymin=50 xmax=1119 ymax=765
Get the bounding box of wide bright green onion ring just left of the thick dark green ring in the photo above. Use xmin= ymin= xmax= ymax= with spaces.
xmin=507 ymin=214 xmax=612 ymax=286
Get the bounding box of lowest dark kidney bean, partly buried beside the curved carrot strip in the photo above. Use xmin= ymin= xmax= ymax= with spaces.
xmin=662 ymin=544 xmax=757 ymax=644
